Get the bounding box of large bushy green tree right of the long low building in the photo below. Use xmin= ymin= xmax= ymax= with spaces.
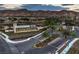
xmin=44 ymin=17 xmax=60 ymax=30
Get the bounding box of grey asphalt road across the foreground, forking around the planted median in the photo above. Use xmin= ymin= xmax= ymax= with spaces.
xmin=0 ymin=37 xmax=72 ymax=54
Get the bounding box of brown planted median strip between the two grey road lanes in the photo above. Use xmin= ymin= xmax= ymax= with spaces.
xmin=33 ymin=34 xmax=59 ymax=48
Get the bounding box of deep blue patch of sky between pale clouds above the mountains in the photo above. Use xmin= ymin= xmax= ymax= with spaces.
xmin=21 ymin=4 xmax=66 ymax=11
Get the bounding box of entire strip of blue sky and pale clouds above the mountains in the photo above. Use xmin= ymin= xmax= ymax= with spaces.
xmin=0 ymin=4 xmax=79 ymax=12
